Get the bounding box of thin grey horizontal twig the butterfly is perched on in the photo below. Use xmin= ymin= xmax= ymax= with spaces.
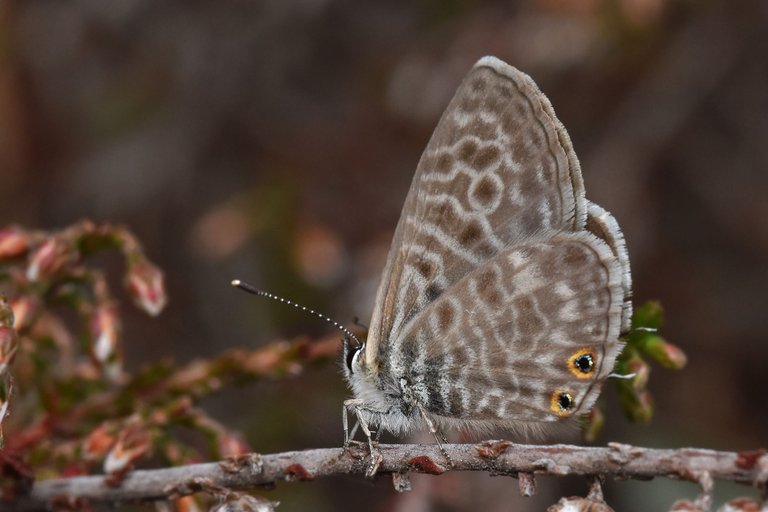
xmin=0 ymin=441 xmax=768 ymax=511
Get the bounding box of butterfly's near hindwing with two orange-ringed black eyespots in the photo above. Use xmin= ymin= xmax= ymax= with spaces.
xmin=390 ymin=231 xmax=624 ymax=423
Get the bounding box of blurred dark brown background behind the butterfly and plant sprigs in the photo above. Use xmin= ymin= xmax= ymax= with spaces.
xmin=0 ymin=0 xmax=768 ymax=512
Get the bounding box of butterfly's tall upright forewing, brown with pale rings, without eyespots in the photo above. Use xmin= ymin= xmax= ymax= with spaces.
xmin=366 ymin=57 xmax=586 ymax=364
